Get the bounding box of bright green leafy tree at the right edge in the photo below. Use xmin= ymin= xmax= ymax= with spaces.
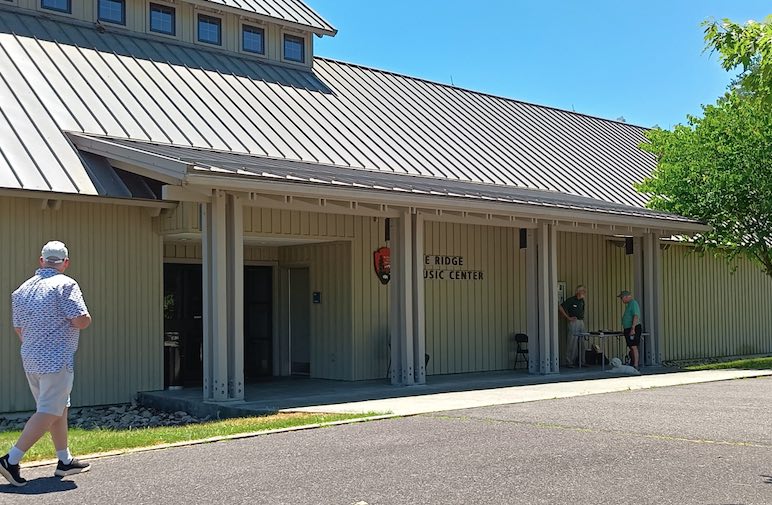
xmin=638 ymin=16 xmax=772 ymax=277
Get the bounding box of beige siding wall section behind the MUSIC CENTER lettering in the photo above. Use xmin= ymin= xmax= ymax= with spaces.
xmin=424 ymin=222 xmax=526 ymax=375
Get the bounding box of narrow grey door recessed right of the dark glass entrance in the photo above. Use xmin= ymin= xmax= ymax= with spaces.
xmin=288 ymin=268 xmax=311 ymax=375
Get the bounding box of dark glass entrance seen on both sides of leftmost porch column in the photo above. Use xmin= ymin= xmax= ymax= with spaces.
xmin=163 ymin=263 xmax=274 ymax=387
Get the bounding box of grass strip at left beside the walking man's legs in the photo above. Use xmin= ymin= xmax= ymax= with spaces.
xmin=0 ymin=413 xmax=376 ymax=462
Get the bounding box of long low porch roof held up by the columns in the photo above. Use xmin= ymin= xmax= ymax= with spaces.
xmin=69 ymin=133 xmax=705 ymax=232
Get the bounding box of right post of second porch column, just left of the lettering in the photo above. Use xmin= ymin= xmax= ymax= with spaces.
xmin=411 ymin=214 xmax=426 ymax=384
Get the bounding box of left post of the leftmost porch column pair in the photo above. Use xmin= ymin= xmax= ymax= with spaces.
xmin=201 ymin=191 xmax=228 ymax=401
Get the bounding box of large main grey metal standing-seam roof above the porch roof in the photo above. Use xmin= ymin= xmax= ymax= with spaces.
xmin=0 ymin=10 xmax=676 ymax=222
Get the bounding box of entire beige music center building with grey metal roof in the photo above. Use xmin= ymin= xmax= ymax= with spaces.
xmin=0 ymin=0 xmax=772 ymax=411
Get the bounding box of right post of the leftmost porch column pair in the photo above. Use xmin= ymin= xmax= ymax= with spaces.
xmin=226 ymin=195 xmax=244 ymax=400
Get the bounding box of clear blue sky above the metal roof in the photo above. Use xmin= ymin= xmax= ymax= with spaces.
xmin=307 ymin=0 xmax=772 ymax=128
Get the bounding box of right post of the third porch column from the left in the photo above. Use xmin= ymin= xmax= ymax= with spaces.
xmin=537 ymin=223 xmax=560 ymax=374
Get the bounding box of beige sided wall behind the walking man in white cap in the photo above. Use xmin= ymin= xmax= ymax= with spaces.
xmin=0 ymin=197 xmax=163 ymax=412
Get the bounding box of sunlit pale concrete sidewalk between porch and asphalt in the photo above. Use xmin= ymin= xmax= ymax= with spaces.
xmin=282 ymin=370 xmax=772 ymax=415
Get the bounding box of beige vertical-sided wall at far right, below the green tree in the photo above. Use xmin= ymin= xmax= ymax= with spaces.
xmin=661 ymin=245 xmax=772 ymax=360
